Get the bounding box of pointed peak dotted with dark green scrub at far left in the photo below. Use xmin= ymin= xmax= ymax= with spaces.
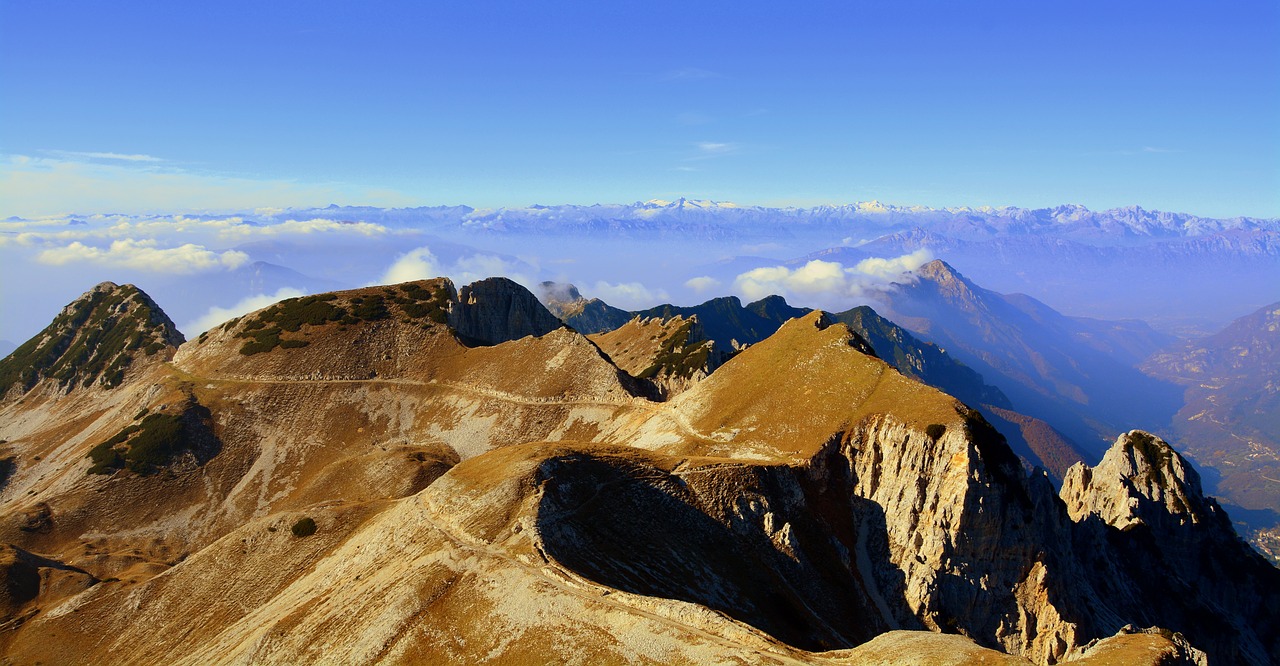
xmin=0 ymin=282 xmax=183 ymax=402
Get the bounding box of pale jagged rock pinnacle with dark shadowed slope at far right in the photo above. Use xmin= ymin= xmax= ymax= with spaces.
xmin=1061 ymin=430 xmax=1280 ymax=663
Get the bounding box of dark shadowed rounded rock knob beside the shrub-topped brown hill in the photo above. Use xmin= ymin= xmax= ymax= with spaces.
xmin=449 ymin=278 xmax=563 ymax=345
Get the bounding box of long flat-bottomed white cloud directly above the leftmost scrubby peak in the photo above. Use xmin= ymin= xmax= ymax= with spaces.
xmin=36 ymin=238 xmax=248 ymax=273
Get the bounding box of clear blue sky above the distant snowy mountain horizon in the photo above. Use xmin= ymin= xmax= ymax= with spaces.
xmin=0 ymin=0 xmax=1280 ymax=216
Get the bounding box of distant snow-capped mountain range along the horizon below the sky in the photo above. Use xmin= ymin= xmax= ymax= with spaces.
xmin=279 ymin=199 xmax=1280 ymax=245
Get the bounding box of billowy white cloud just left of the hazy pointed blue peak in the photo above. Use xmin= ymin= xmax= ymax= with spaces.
xmin=733 ymin=250 xmax=931 ymax=307
